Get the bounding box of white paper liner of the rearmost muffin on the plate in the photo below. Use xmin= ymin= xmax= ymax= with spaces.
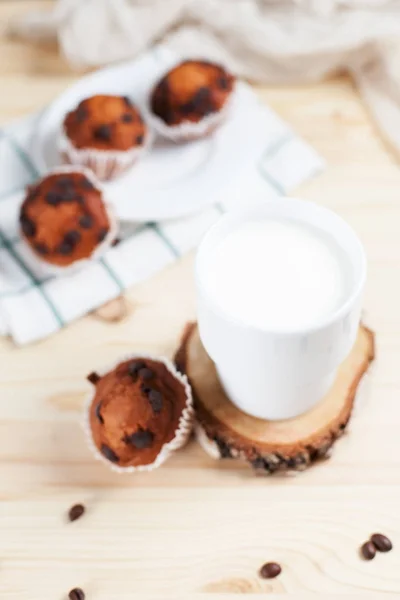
xmin=144 ymin=83 xmax=237 ymax=142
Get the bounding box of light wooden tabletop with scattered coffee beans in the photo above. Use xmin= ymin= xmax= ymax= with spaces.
xmin=0 ymin=1 xmax=400 ymax=600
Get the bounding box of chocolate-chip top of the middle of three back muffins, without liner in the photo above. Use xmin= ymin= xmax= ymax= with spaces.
xmin=64 ymin=95 xmax=147 ymax=151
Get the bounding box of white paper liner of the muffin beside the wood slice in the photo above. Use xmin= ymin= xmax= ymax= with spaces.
xmin=83 ymin=353 xmax=194 ymax=474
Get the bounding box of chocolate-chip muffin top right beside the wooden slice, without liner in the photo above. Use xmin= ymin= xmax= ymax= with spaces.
xmin=88 ymin=358 xmax=186 ymax=467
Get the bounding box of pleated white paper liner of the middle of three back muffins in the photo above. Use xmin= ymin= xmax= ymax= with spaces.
xmin=58 ymin=130 xmax=152 ymax=181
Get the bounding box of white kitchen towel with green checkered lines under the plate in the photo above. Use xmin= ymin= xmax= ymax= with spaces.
xmin=0 ymin=89 xmax=323 ymax=345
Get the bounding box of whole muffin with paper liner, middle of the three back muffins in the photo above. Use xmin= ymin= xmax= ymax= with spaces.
xmin=60 ymin=95 xmax=149 ymax=179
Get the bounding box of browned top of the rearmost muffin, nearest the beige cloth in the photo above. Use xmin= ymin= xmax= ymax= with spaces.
xmin=151 ymin=60 xmax=235 ymax=125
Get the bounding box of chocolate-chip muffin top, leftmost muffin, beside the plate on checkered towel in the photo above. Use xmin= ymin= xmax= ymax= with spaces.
xmin=20 ymin=171 xmax=111 ymax=266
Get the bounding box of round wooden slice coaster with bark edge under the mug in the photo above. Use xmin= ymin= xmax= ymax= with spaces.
xmin=176 ymin=324 xmax=374 ymax=473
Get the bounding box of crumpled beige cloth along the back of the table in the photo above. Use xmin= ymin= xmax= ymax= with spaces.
xmin=11 ymin=0 xmax=400 ymax=156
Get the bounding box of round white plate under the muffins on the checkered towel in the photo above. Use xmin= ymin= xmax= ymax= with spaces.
xmin=32 ymin=47 xmax=276 ymax=222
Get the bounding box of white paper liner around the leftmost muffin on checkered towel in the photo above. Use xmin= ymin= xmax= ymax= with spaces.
xmin=21 ymin=165 xmax=118 ymax=276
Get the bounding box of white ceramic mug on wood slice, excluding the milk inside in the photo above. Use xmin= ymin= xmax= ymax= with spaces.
xmin=195 ymin=198 xmax=366 ymax=420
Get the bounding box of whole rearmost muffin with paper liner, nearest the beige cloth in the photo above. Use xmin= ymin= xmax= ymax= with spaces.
xmin=150 ymin=60 xmax=235 ymax=141
